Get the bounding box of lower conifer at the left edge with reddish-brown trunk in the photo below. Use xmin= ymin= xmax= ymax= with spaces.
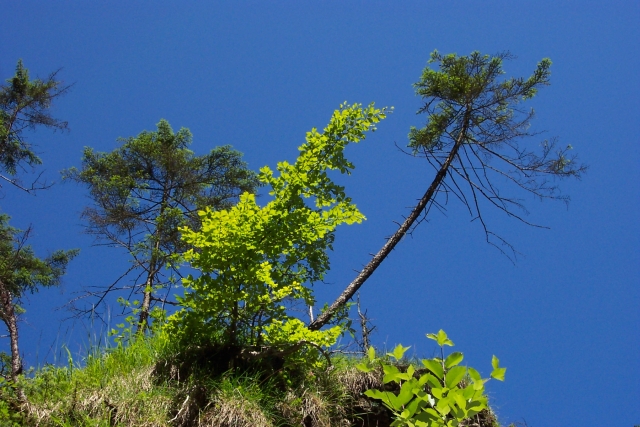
xmin=0 ymin=214 xmax=78 ymax=396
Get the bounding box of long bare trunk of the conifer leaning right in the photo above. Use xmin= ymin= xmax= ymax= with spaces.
xmin=309 ymin=118 xmax=469 ymax=330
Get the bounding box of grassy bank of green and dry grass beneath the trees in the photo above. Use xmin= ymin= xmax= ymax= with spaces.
xmin=0 ymin=336 xmax=504 ymax=427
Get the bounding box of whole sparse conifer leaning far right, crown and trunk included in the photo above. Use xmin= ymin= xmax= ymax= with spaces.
xmin=310 ymin=51 xmax=586 ymax=330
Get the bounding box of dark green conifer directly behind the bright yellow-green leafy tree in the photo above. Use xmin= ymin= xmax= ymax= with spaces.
xmin=63 ymin=120 xmax=258 ymax=331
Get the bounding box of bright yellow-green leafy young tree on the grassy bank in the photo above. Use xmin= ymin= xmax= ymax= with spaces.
xmin=166 ymin=104 xmax=385 ymax=364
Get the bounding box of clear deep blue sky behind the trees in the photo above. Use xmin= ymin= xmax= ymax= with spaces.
xmin=0 ymin=1 xmax=640 ymax=427
